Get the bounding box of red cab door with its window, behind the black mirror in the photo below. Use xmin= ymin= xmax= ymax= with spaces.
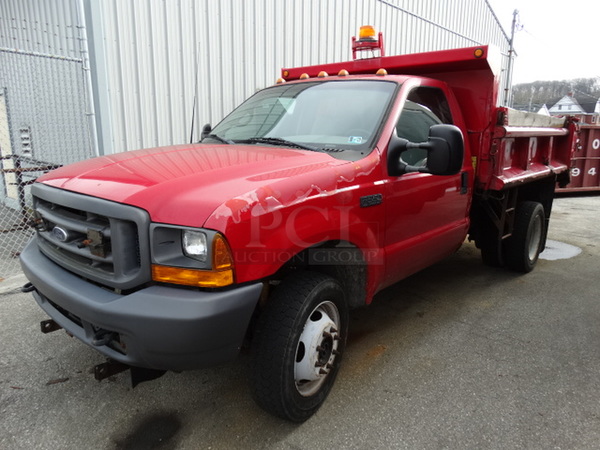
xmin=384 ymin=86 xmax=469 ymax=286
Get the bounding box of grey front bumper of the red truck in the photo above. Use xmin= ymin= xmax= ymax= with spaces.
xmin=21 ymin=238 xmax=262 ymax=370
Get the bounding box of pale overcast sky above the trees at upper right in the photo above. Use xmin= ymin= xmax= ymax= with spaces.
xmin=488 ymin=0 xmax=600 ymax=84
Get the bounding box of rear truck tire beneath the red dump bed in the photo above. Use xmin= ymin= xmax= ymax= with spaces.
xmin=504 ymin=201 xmax=546 ymax=273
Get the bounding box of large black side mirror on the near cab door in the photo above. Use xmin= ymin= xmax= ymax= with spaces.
xmin=387 ymin=124 xmax=465 ymax=176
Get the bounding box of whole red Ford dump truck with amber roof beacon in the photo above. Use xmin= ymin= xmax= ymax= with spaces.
xmin=21 ymin=28 xmax=576 ymax=421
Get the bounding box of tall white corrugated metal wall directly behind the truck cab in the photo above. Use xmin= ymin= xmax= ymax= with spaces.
xmin=85 ymin=0 xmax=508 ymax=153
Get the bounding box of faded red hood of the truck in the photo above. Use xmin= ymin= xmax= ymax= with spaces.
xmin=38 ymin=144 xmax=349 ymax=226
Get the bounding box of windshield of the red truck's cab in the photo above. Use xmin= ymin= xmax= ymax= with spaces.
xmin=211 ymin=80 xmax=397 ymax=158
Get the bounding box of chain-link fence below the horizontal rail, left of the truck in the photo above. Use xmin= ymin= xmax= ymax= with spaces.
xmin=0 ymin=48 xmax=94 ymax=279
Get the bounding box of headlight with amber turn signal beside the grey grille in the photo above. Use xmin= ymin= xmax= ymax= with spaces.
xmin=150 ymin=224 xmax=235 ymax=287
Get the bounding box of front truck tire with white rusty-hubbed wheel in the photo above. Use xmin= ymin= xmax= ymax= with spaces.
xmin=252 ymin=272 xmax=348 ymax=422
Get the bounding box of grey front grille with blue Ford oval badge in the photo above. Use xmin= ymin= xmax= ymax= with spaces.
xmin=31 ymin=183 xmax=150 ymax=289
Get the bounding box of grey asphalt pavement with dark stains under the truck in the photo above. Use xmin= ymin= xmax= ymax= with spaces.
xmin=0 ymin=196 xmax=600 ymax=449
